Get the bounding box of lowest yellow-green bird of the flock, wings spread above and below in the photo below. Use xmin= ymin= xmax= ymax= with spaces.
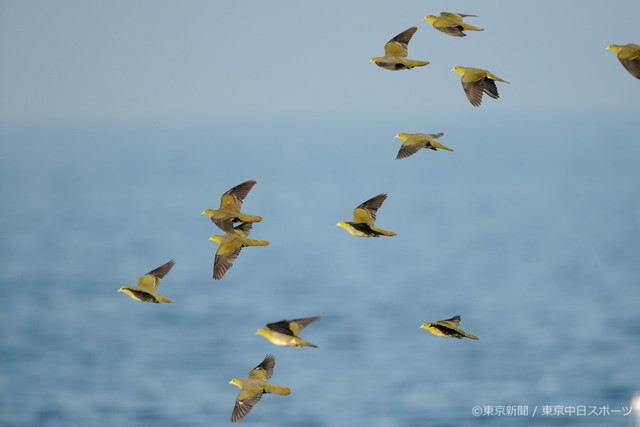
xmin=229 ymin=354 xmax=291 ymax=422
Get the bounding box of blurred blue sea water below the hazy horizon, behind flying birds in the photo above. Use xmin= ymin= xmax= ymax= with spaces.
xmin=0 ymin=114 xmax=640 ymax=427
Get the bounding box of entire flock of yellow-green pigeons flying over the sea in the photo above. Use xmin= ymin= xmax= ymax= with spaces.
xmin=118 ymin=12 xmax=640 ymax=422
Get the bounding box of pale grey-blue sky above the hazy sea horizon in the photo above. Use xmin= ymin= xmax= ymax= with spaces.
xmin=0 ymin=0 xmax=640 ymax=124
